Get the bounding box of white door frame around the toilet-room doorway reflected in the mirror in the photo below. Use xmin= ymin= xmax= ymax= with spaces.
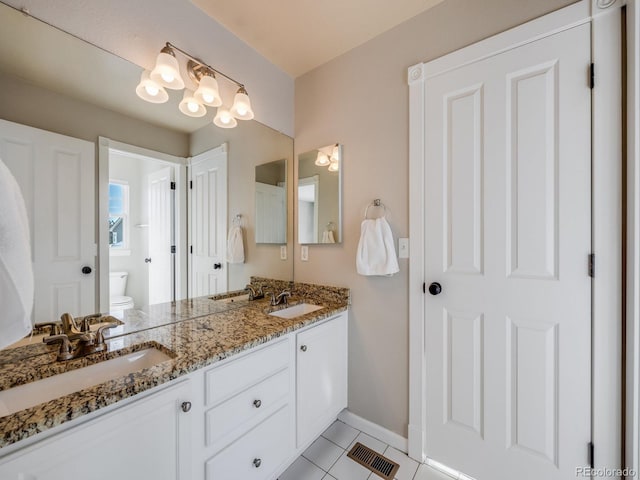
xmin=96 ymin=137 xmax=187 ymax=312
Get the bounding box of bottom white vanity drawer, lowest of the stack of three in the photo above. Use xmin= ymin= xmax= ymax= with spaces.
xmin=205 ymin=405 xmax=293 ymax=480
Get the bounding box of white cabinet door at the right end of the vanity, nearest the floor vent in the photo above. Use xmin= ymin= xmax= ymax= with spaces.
xmin=296 ymin=312 xmax=348 ymax=448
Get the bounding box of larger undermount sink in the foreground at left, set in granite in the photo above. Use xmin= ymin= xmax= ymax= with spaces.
xmin=0 ymin=347 xmax=172 ymax=417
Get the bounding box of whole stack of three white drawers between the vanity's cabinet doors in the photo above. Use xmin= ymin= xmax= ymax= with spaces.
xmin=203 ymin=335 xmax=295 ymax=480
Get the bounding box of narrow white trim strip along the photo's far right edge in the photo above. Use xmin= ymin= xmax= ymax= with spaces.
xmin=625 ymin=0 xmax=640 ymax=480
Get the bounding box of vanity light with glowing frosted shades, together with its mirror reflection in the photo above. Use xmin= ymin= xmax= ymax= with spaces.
xmin=136 ymin=42 xmax=254 ymax=128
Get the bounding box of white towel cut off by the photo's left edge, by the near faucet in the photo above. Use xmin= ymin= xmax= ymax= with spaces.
xmin=0 ymin=160 xmax=33 ymax=348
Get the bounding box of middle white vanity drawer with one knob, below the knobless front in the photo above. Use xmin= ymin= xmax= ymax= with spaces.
xmin=205 ymin=368 xmax=291 ymax=447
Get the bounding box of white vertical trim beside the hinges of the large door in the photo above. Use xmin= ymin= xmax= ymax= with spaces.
xmin=591 ymin=5 xmax=622 ymax=468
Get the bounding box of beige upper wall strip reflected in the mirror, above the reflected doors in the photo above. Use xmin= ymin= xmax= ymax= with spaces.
xmin=0 ymin=72 xmax=189 ymax=157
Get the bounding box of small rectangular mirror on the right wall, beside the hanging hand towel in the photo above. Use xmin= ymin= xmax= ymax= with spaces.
xmin=298 ymin=143 xmax=342 ymax=244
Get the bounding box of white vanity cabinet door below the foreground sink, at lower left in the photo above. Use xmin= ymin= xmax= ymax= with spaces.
xmin=0 ymin=380 xmax=192 ymax=480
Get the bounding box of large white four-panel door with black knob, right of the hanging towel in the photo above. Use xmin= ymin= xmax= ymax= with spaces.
xmin=424 ymin=24 xmax=591 ymax=480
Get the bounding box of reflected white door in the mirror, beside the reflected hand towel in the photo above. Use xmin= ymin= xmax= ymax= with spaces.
xmin=189 ymin=146 xmax=227 ymax=297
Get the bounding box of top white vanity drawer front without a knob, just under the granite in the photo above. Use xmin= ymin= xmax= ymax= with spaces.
xmin=205 ymin=337 xmax=290 ymax=406
